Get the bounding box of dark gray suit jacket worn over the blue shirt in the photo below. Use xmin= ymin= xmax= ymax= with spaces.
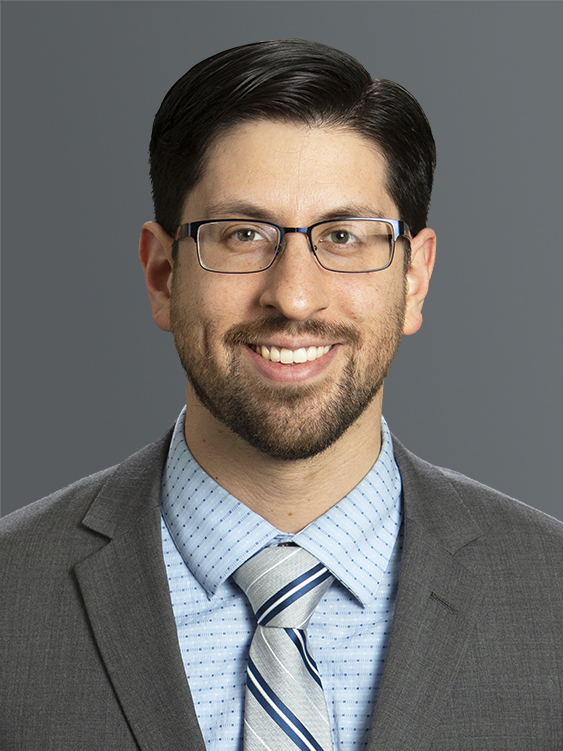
xmin=0 ymin=434 xmax=563 ymax=751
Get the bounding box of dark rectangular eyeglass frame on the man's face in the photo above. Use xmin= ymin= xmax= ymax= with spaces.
xmin=174 ymin=216 xmax=412 ymax=274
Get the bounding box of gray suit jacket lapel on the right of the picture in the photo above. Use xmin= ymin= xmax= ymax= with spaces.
xmin=368 ymin=442 xmax=481 ymax=751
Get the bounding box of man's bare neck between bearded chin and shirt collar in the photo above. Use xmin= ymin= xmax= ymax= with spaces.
xmin=185 ymin=389 xmax=382 ymax=533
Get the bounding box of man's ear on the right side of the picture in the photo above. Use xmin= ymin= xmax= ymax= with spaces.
xmin=403 ymin=227 xmax=436 ymax=334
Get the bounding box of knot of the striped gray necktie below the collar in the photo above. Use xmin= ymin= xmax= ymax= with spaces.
xmin=233 ymin=546 xmax=333 ymax=629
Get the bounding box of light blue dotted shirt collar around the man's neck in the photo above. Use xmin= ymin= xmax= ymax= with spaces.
xmin=161 ymin=408 xmax=402 ymax=607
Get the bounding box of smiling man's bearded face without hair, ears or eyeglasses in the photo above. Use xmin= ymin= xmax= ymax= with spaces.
xmin=170 ymin=121 xmax=412 ymax=460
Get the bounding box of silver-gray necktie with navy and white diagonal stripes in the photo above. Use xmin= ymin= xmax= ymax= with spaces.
xmin=234 ymin=546 xmax=333 ymax=751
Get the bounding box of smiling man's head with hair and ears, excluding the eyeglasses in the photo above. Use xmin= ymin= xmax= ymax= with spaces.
xmin=140 ymin=40 xmax=435 ymax=460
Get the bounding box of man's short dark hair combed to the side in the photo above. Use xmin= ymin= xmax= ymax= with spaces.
xmin=150 ymin=39 xmax=436 ymax=236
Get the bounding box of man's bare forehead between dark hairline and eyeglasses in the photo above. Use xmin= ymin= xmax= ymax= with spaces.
xmin=184 ymin=120 xmax=399 ymax=226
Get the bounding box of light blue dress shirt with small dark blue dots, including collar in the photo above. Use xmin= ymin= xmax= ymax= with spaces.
xmin=161 ymin=409 xmax=402 ymax=751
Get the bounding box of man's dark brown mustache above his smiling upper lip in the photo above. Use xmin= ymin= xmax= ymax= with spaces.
xmin=225 ymin=316 xmax=361 ymax=346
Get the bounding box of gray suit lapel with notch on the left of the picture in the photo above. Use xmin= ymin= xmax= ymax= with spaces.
xmin=75 ymin=436 xmax=205 ymax=751
